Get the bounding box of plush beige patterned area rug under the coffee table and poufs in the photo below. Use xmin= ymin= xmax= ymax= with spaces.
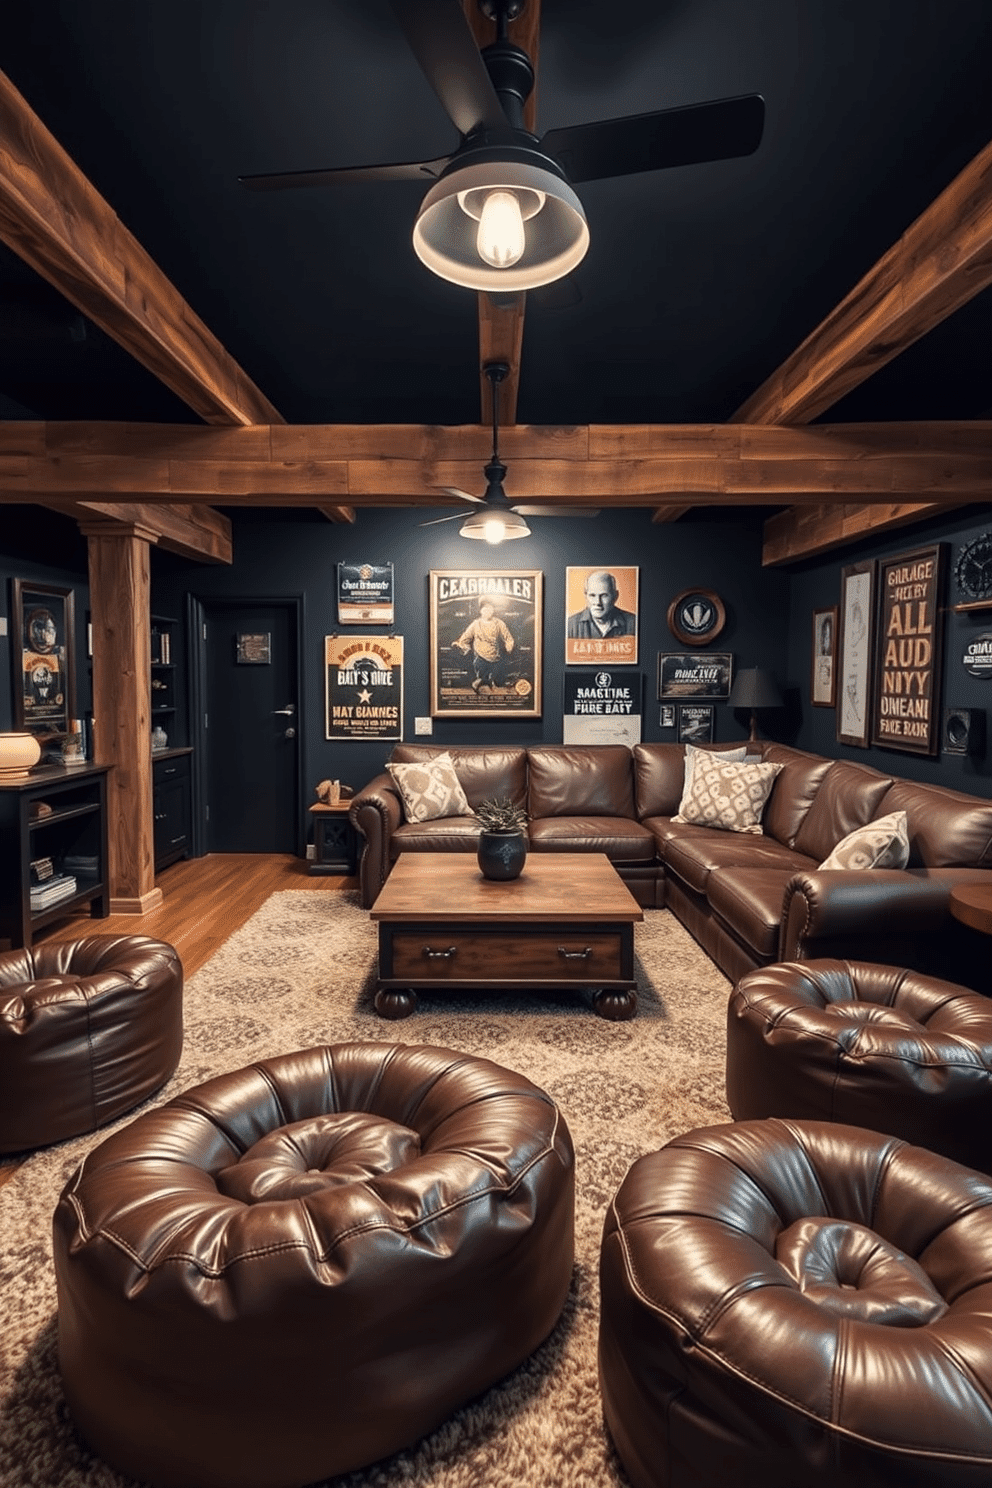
xmin=0 ymin=891 xmax=729 ymax=1488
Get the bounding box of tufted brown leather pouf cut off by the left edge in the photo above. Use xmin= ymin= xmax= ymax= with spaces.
xmin=0 ymin=934 xmax=183 ymax=1153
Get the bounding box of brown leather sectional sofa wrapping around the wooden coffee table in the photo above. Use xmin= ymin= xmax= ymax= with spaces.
xmin=351 ymin=740 xmax=992 ymax=990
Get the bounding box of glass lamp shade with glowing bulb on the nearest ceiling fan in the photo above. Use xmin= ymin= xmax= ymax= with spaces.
xmin=413 ymin=159 xmax=589 ymax=292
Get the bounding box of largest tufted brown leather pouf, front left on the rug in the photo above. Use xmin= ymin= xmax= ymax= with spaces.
xmin=55 ymin=1043 xmax=574 ymax=1488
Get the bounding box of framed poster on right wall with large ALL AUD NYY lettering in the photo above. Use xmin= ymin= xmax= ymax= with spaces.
xmin=872 ymin=543 xmax=947 ymax=754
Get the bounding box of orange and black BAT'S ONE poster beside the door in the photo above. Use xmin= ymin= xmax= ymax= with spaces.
xmin=324 ymin=635 xmax=403 ymax=740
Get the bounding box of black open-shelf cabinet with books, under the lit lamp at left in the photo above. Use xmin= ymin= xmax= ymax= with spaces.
xmin=0 ymin=765 xmax=110 ymax=948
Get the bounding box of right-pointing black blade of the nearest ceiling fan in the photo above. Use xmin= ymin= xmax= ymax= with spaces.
xmin=541 ymin=94 xmax=764 ymax=182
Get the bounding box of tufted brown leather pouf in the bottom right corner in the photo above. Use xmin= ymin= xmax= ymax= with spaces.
xmin=599 ymin=1120 xmax=992 ymax=1488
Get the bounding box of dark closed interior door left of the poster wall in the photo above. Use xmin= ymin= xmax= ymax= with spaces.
xmin=202 ymin=603 xmax=299 ymax=853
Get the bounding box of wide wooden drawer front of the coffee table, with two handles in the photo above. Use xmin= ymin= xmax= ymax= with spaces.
xmin=390 ymin=930 xmax=623 ymax=982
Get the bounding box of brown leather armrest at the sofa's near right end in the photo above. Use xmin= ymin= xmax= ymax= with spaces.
xmin=779 ymin=868 xmax=992 ymax=970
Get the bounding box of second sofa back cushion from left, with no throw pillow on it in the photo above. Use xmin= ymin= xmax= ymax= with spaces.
xmin=526 ymin=744 xmax=634 ymax=818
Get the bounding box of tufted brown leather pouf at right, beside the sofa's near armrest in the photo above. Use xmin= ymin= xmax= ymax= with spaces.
xmin=727 ymin=961 xmax=992 ymax=1171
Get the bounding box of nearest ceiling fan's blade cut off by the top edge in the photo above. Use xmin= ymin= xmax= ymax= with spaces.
xmin=390 ymin=0 xmax=509 ymax=134
